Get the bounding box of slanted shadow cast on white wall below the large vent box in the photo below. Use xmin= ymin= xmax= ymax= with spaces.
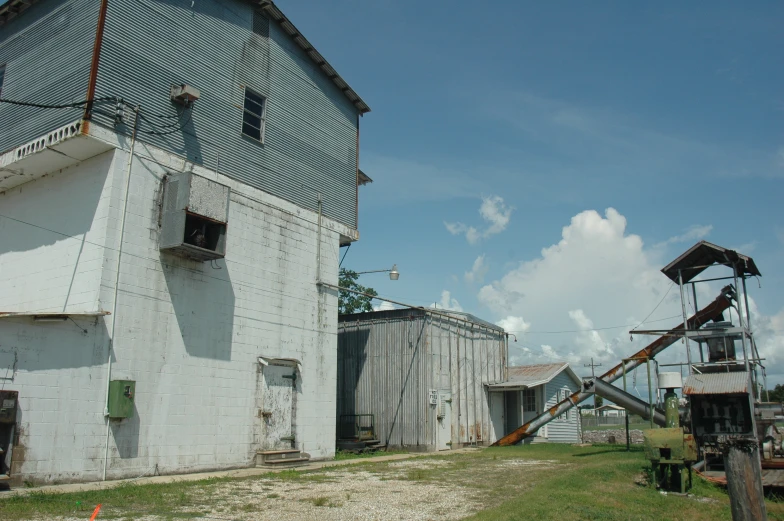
xmin=160 ymin=253 xmax=235 ymax=360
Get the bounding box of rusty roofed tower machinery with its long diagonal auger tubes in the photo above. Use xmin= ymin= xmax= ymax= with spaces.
xmin=496 ymin=241 xmax=784 ymax=519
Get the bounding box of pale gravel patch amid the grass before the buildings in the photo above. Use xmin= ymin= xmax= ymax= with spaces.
xmin=47 ymin=455 xmax=559 ymax=521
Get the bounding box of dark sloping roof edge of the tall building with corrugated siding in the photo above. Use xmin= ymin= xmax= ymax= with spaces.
xmin=0 ymin=0 xmax=370 ymax=114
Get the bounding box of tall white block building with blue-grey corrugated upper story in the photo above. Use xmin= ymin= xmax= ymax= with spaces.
xmin=0 ymin=0 xmax=369 ymax=483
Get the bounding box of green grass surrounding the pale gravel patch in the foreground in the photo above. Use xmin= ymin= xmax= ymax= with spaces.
xmin=0 ymin=444 xmax=784 ymax=521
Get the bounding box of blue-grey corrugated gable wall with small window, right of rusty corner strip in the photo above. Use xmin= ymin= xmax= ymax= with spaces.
xmin=96 ymin=0 xmax=358 ymax=227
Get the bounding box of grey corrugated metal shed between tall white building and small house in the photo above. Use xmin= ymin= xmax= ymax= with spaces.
xmin=337 ymin=309 xmax=508 ymax=451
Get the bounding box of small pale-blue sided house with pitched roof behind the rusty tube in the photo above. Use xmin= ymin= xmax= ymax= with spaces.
xmin=487 ymin=362 xmax=581 ymax=443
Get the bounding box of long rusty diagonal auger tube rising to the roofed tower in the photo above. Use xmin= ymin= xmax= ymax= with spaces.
xmin=493 ymin=286 xmax=736 ymax=446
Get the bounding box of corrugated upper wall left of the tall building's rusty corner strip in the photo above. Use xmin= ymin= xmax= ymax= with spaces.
xmin=0 ymin=0 xmax=100 ymax=153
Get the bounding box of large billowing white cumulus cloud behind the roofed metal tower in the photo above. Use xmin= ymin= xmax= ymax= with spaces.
xmin=478 ymin=208 xmax=784 ymax=382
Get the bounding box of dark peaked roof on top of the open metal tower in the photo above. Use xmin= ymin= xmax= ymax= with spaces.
xmin=662 ymin=241 xmax=762 ymax=284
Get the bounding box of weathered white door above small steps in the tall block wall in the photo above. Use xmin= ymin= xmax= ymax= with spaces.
xmin=261 ymin=364 xmax=296 ymax=450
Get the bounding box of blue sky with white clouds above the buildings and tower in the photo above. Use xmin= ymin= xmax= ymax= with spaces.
xmin=277 ymin=0 xmax=784 ymax=387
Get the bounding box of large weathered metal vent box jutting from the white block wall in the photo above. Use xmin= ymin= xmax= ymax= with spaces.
xmin=160 ymin=172 xmax=231 ymax=261
